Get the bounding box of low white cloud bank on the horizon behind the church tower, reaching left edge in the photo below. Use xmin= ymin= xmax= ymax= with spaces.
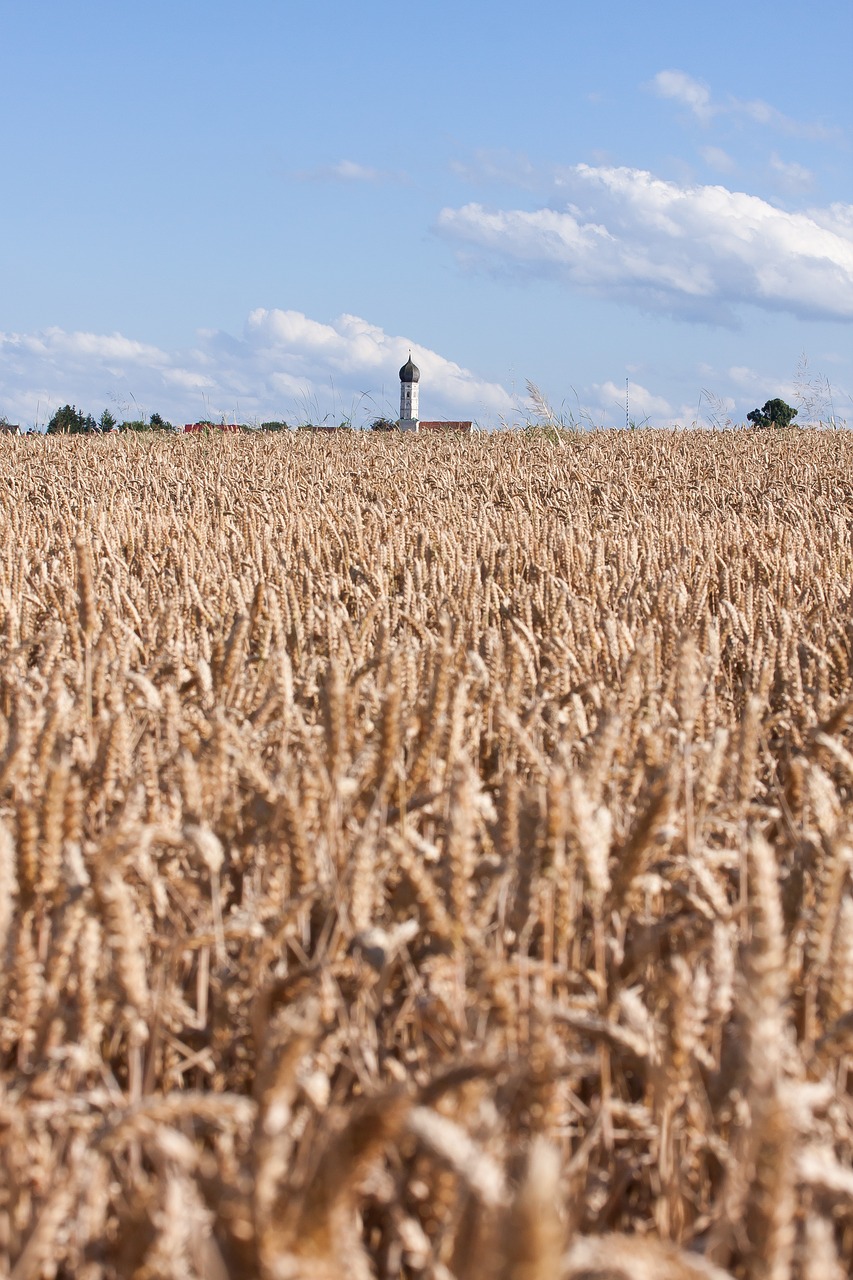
xmin=0 ymin=307 xmax=512 ymax=425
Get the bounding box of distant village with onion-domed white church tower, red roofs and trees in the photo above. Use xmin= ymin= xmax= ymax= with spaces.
xmin=0 ymin=351 xmax=474 ymax=435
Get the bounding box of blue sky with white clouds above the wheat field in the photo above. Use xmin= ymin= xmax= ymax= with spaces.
xmin=0 ymin=0 xmax=853 ymax=425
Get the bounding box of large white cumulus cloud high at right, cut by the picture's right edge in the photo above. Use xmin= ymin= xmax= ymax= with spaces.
xmin=438 ymin=164 xmax=853 ymax=324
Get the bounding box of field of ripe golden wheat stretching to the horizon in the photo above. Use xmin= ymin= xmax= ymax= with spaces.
xmin=0 ymin=431 xmax=853 ymax=1280
